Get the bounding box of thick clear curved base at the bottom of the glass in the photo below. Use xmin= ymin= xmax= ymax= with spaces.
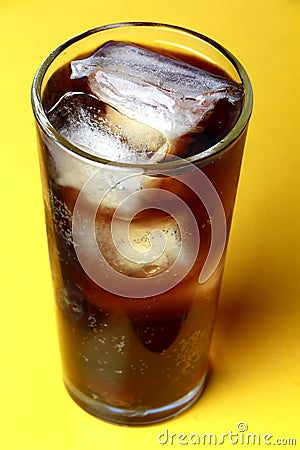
xmin=64 ymin=374 xmax=206 ymax=425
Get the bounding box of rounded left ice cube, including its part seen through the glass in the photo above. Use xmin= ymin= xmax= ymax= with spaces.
xmin=48 ymin=92 xmax=168 ymax=217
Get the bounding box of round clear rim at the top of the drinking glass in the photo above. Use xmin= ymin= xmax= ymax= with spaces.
xmin=31 ymin=22 xmax=253 ymax=171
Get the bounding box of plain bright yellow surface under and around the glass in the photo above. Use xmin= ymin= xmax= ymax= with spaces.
xmin=0 ymin=0 xmax=300 ymax=450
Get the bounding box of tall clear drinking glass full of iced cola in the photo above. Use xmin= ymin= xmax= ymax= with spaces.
xmin=32 ymin=23 xmax=252 ymax=424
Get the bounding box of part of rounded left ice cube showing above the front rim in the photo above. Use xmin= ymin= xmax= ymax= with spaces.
xmin=48 ymin=92 xmax=168 ymax=163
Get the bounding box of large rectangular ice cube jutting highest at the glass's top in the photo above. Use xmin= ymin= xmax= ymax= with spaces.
xmin=71 ymin=41 xmax=243 ymax=140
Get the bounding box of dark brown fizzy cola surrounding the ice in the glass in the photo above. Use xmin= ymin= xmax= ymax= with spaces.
xmin=41 ymin=43 xmax=243 ymax=422
